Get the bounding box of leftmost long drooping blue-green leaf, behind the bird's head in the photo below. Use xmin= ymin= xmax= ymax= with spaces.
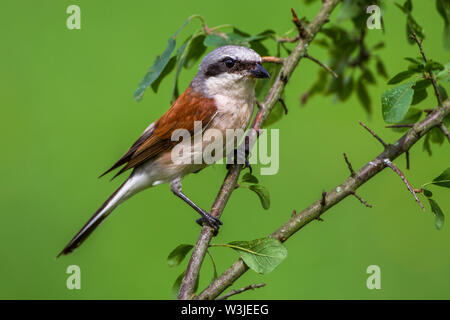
xmin=134 ymin=16 xmax=193 ymax=101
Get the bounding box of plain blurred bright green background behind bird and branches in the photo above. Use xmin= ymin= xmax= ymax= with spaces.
xmin=0 ymin=0 xmax=450 ymax=299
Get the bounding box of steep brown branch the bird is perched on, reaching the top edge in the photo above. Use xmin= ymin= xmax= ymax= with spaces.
xmin=178 ymin=0 xmax=340 ymax=299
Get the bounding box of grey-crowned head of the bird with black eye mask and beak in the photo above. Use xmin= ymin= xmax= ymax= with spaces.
xmin=192 ymin=45 xmax=270 ymax=93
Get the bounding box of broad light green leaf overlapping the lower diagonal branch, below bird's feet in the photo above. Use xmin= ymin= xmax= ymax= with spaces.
xmin=228 ymin=238 xmax=287 ymax=274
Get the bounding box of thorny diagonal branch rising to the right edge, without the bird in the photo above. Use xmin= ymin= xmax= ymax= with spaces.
xmin=200 ymin=99 xmax=450 ymax=299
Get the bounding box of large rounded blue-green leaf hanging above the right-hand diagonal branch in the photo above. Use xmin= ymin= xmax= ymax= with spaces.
xmin=381 ymin=82 xmax=414 ymax=123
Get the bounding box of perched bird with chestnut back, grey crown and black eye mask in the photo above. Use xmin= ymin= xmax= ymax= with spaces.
xmin=57 ymin=45 xmax=270 ymax=257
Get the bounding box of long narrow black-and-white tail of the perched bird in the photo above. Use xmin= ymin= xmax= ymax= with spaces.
xmin=57 ymin=177 xmax=138 ymax=258
